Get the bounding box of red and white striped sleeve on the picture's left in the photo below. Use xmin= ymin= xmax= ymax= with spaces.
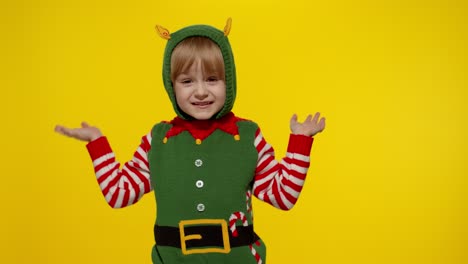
xmin=86 ymin=132 xmax=152 ymax=208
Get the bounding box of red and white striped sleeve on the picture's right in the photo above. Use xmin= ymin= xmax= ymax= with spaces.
xmin=253 ymin=129 xmax=314 ymax=210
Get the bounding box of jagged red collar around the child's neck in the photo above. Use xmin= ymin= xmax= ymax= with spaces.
xmin=164 ymin=112 xmax=244 ymax=144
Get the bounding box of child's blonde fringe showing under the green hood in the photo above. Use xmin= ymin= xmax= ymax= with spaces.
xmin=171 ymin=37 xmax=225 ymax=82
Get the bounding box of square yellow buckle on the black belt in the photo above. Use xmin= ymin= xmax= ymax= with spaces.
xmin=179 ymin=219 xmax=231 ymax=255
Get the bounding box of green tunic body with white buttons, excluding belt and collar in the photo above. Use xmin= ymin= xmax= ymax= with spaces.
xmin=148 ymin=121 xmax=266 ymax=264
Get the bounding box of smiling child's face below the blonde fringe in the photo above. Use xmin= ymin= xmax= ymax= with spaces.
xmin=173 ymin=60 xmax=226 ymax=120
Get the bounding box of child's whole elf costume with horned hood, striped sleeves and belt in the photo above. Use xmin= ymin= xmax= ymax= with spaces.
xmin=87 ymin=20 xmax=313 ymax=264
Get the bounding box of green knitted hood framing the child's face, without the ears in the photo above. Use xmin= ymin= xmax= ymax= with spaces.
xmin=163 ymin=25 xmax=236 ymax=120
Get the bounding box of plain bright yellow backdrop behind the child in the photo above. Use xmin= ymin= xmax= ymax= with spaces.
xmin=0 ymin=0 xmax=468 ymax=264
